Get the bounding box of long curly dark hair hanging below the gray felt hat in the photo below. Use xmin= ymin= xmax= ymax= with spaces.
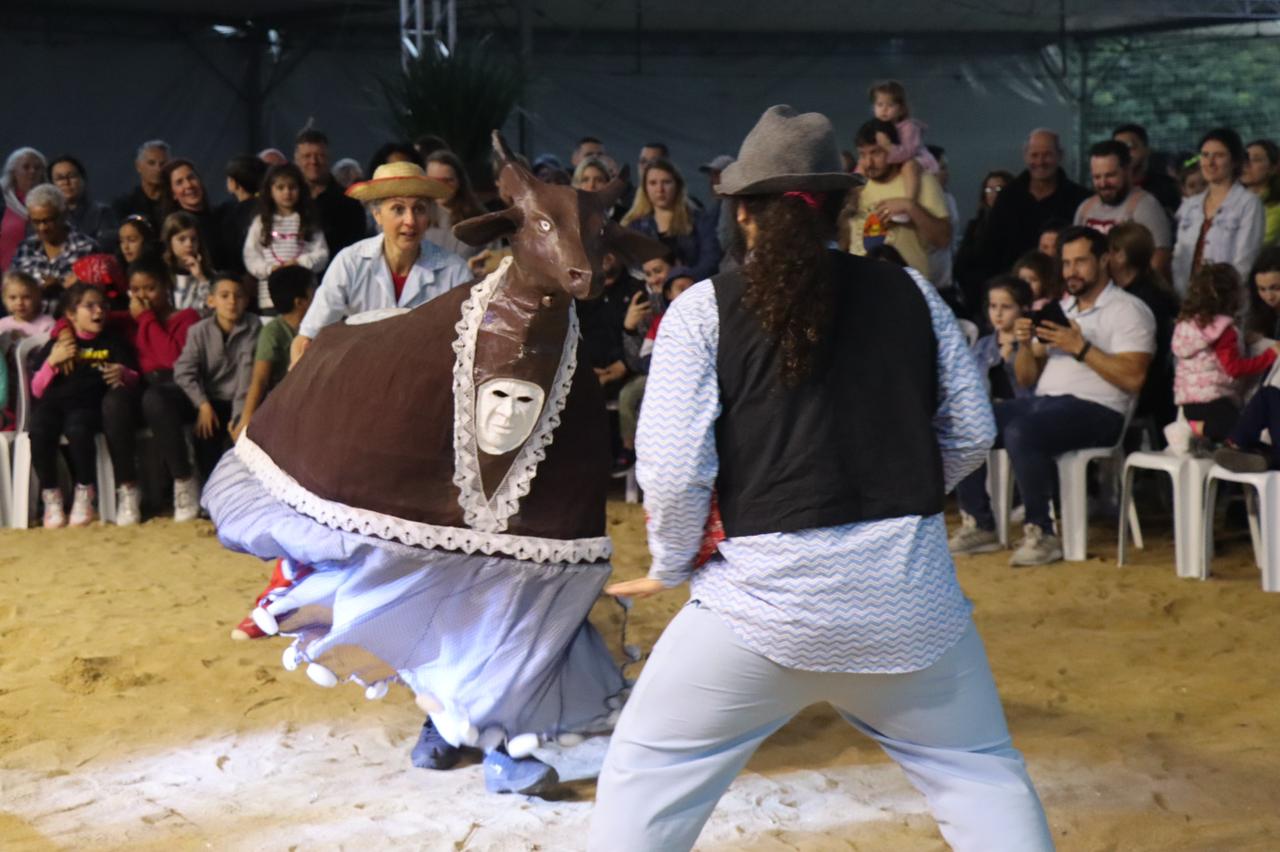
xmin=739 ymin=193 xmax=844 ymax=388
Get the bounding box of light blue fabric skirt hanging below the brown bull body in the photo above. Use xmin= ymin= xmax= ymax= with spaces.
xmin=202 ymin=452 xmax=625 ymax=750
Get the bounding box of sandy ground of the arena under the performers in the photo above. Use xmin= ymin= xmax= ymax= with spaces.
xmin=0 ymin=493 xmax=1280 ymax=852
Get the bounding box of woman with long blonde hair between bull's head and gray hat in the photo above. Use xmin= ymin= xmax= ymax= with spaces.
xmin=622 ymin=158 xmax=721 ymax=280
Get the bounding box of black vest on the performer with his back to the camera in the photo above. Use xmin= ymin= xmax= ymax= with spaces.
xmin=712 ymin=252 xmax=943 ymax=536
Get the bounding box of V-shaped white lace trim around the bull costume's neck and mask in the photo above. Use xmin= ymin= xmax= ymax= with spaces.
xmin=453 ymin=257 xmax=577 ymax=532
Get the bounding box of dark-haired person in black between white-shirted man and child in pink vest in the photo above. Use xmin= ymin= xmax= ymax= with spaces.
xmin=1107 ymin=221 xmax=1178 ymax=432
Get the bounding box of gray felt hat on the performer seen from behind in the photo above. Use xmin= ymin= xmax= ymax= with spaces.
xmin=717 ymin=104 xmax=864 ymax=196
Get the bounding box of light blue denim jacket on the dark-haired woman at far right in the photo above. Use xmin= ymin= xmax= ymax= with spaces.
xmin=1174 ymin=180 xmax=1267 ymax=297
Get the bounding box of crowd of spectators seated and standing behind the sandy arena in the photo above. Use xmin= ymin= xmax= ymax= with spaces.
xmin=0 ymin=91 xmax=1280 ymax=564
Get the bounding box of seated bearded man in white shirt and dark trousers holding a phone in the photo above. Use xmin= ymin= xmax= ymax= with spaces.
xmin=951 ymin=228 xmax=1156 ymax=565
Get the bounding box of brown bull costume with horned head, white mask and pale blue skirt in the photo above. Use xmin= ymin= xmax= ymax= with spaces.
xmin=204 ymin=133 xmax=660 ymax=792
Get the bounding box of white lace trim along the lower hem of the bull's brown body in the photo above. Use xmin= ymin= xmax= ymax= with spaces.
xmin=236 ymin=435 xmax=613 ymax=563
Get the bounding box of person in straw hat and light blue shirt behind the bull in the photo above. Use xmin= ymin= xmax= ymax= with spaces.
xmin=291 ymin=162 xmax=471 ymax=361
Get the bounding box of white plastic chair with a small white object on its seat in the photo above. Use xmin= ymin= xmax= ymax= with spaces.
xmin=1116 ymin=453 xmax=1213 ymax=580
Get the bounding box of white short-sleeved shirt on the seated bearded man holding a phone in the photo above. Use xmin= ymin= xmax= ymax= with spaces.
xmin=1036 ymin=281 xmax=1156 ymax=414
